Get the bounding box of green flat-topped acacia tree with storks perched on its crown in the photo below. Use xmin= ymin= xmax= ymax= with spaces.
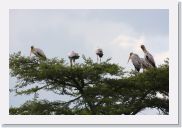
xmin=9 ymin=53 xmax=169 ymax=115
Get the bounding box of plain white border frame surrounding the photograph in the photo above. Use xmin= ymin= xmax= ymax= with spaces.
xmin=0 ymin=0 xmax=179 ymax=125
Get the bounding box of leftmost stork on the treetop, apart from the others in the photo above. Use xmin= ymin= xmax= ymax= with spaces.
xmin=30 ymin=46 xmax=46 ymax=60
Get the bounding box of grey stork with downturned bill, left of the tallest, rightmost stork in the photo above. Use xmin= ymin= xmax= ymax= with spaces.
xmin=128 ymin=52 xmax=141 ymax=72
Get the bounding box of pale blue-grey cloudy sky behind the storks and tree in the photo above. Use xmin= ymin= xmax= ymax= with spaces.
xmin=9 ymin=9 xmax=169 ymax=114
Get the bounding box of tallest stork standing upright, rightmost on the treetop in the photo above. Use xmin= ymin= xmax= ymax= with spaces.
xmin=141 ymin=45 xmax=156 ymax=67
